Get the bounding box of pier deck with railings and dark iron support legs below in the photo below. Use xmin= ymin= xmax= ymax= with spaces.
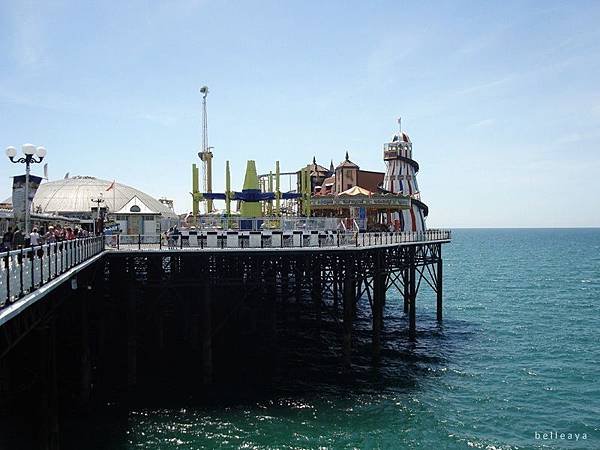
xmin=0 ymin=230 xmax=451 ymax=448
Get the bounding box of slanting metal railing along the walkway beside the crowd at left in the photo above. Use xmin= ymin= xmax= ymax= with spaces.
xmin=0 ymin=236 xmax=104 ymax=308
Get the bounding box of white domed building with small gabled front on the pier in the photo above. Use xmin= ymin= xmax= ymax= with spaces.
xmin=32 ymin=176 xmax=177 ymax=234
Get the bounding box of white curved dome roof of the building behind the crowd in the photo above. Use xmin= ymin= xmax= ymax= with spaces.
xmin=33 ymin=177 xmax=175 ymax=217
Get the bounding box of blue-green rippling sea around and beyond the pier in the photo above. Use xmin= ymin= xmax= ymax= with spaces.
xmin=61 ymin=228 xmax=600 ymax=450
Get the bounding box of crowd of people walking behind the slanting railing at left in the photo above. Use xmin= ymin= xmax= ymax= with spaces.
xmin=0 ymin=225 xmax=90 ymax=252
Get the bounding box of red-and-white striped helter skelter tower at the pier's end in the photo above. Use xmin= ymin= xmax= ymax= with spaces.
xmin=383 ymin=119 xmax=428 ymax=231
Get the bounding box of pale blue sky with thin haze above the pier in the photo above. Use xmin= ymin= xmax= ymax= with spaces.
xmin=0 ymin=0 xmax=600 ymax=227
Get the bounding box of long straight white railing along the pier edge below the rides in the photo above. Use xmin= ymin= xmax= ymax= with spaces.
xmin=105 ymin=230 xmax=452 ymax=251
